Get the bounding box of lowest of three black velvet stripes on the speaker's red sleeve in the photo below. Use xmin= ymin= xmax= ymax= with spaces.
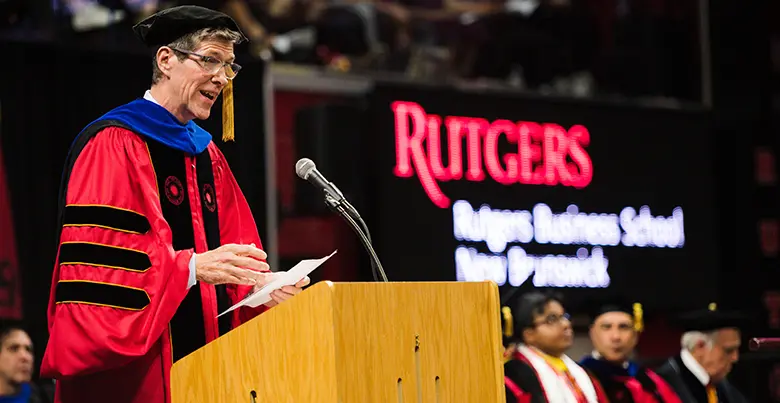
xmin=55 ymin=280 xmax=150 ymax=311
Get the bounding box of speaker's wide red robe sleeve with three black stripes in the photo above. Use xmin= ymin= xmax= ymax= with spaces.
xmin=41 ymin=128 xmax=193 ymax=378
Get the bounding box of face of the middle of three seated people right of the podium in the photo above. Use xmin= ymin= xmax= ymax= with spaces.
xmin=590 ymin=312 xmax=637 ymax=363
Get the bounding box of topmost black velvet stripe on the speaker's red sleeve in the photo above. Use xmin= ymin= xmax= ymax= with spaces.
xmin=63 ymin=205 xmax=150 ymax=234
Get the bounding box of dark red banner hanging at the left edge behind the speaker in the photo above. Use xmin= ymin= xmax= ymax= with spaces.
xmin=0 ymin=145 xmax=22 ymax=319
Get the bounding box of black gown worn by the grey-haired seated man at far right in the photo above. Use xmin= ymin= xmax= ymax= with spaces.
xmin=655 ymin=355 xmax=748 ymax=403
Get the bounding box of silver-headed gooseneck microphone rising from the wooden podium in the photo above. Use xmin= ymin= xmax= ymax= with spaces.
xmin=295 ymin=158 xmax=388 ymax=282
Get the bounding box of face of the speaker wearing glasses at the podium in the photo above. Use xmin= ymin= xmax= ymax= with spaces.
xmin=169 ymin=40 xmax=235 ymax=120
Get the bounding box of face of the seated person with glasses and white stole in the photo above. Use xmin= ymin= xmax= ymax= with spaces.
xmin=523 ymin=301 xmax=574 ymax=357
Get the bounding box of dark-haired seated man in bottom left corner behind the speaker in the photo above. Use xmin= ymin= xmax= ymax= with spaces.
xmin=0 ymin=325 xmax=50 ymax=403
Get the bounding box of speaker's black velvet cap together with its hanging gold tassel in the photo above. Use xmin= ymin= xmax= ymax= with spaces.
xmin=133 ymin=6 xmax=248 ymax=141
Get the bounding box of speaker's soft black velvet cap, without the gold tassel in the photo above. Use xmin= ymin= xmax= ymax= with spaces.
xmin=133 ymin=6 xmax=248 ymax=47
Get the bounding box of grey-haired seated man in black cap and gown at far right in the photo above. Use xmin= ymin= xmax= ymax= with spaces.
xmin=656 ymin=304 xmax=747 ymax=403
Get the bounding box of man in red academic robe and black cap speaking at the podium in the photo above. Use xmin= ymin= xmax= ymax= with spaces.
xmin=41 ymin=6 xmax=308 ymax=403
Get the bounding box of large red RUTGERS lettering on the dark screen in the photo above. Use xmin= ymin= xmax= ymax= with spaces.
xmin=392 ymin=101 xmax=593 ymax=208
